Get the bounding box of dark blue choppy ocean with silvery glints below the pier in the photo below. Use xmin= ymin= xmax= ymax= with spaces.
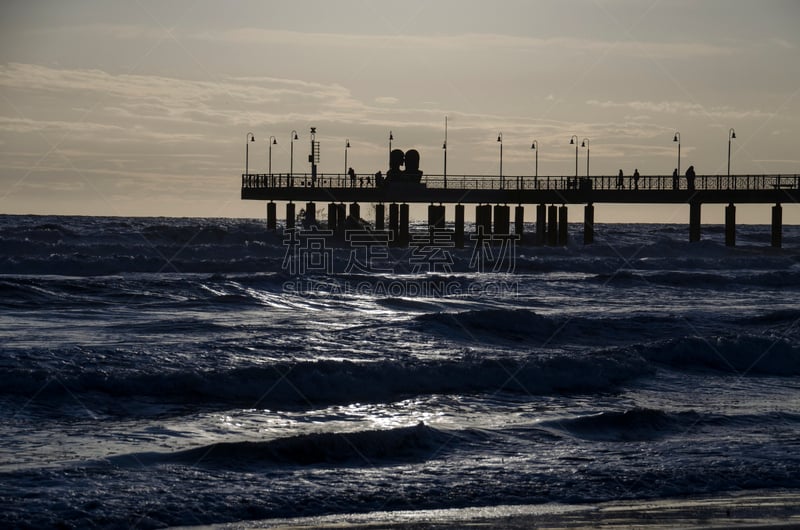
xmin=0 ymin=212 xmax=800 ymax=529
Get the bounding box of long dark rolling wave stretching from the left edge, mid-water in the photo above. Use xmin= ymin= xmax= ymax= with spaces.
xmin=0 ymin=354 xmax=652 ymax=408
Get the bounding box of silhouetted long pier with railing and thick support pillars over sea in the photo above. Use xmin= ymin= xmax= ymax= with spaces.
xmin=241 ymin=172 xmax=800 ymax=248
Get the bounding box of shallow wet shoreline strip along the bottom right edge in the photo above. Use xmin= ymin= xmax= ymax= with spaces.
xmin=194 ymin=490 xmax=800 ymax=530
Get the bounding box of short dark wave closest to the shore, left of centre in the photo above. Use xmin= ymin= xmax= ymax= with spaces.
xmin=108 ymin=422 xmax=456 ymax=467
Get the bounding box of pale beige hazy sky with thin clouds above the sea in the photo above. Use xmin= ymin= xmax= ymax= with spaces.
xmin=0 ymin=0 xmax=800 ymax=224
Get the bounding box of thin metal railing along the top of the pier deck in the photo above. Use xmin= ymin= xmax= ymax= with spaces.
xmin=242 ymin=173 xmax=800 ymax=191
